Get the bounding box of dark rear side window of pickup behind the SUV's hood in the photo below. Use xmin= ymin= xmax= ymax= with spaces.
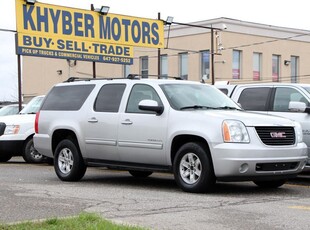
xmin=238 ymin=87 xmax=271 ymax=111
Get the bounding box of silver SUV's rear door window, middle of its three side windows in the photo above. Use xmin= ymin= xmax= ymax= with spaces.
xmin=94 ymin=84 xmax=126 ymax=113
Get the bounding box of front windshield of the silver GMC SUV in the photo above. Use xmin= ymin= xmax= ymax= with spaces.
xmin=161 ymin=84 xmax=240 ymax=110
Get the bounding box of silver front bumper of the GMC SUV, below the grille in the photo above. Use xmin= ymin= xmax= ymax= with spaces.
xmin=211 ymin=143 xmax=308 ymax=181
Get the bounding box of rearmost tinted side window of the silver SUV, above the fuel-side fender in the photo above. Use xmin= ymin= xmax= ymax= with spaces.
xmin=41 ymin=85 xmax=95 ymax=111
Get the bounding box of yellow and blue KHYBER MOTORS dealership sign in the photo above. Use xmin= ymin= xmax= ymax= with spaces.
xmin=16 ymin=0 xmax=164 ymax=64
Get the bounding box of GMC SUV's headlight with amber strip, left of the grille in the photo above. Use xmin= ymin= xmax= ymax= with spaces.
xmin=222 ymin=120 xmax=250 ymax=143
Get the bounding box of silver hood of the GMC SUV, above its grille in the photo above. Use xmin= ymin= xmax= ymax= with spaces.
xmin=188 ymin=110 xmax=295 ymax=127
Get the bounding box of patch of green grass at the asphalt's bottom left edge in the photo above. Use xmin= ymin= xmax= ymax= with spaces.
xmin=0 ymin=213 xmax=145 ymax=230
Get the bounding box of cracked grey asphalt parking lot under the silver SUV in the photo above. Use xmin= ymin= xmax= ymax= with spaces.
xmin=0 ymin=157 xmax=310 ymax=230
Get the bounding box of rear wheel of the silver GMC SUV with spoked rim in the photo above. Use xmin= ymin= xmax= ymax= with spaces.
xmin=54 ymin=139 xmax=87 ymax=181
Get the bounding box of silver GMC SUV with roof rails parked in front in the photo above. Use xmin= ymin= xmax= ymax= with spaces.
xmin=34 ymin=79 xmax=307 ymax=192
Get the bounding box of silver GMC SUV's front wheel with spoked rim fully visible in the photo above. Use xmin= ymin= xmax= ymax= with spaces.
xmin=173 ymin=142 xmax=215 ymax=193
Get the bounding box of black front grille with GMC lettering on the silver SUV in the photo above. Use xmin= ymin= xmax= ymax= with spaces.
xmin=255 ymin=126 xmax=295 ymax=145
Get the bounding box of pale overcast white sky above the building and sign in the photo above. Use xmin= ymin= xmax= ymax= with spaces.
xmin=0 ymin=0 xmax=310 ymax=102
